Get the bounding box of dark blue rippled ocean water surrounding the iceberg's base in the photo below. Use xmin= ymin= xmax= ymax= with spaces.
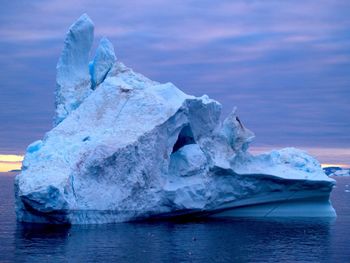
xmin=0 ymin=173 xmax=350 ymax=263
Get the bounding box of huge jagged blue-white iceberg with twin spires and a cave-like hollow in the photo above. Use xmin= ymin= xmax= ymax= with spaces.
xmin=15 ymin=15 xmax=335 ymax=224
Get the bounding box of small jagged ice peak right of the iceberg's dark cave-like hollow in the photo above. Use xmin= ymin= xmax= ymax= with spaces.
xmin=223 ymin=107 xmax=255 ymax=152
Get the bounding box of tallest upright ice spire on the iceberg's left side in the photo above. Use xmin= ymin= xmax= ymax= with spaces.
xmin=54 ymin=14 xmax=94 ymax=125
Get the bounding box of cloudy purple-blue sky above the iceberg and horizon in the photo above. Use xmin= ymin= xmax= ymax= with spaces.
xmin=0 ymin=0 xmax=350 ymax=170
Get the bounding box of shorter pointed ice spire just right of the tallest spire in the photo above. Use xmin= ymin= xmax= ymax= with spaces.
xmin=90 ymin=37 xmax=117 ymax=89
